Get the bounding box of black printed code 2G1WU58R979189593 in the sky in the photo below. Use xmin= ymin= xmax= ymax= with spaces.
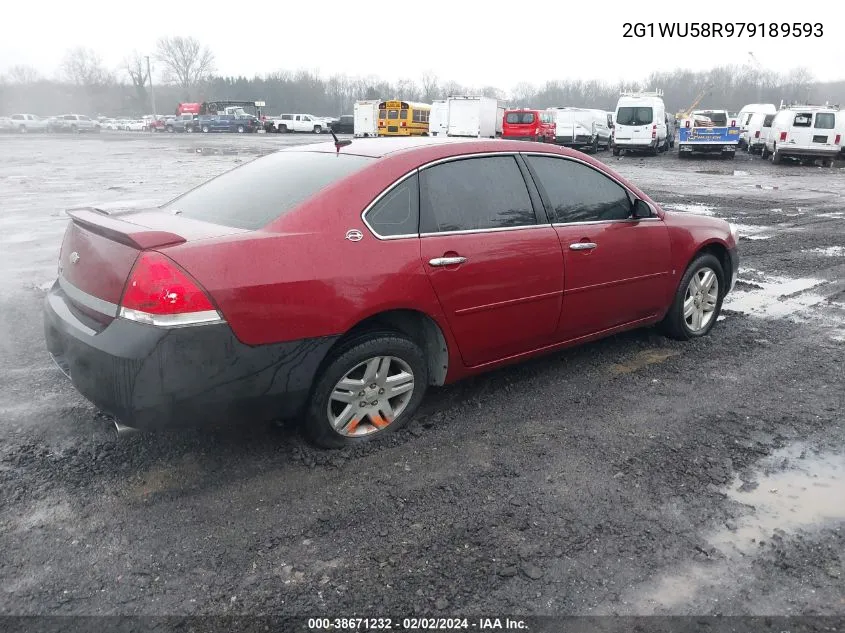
xmin=622 ymin=22 xmax=824 ymax=38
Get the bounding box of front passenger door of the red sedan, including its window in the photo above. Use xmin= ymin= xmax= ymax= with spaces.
xmin=526 ymin=154 xmax=670 ymax=340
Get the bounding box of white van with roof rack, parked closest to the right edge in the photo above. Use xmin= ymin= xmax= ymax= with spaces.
xmin=763 ymin=106 xmax=842 ymax=166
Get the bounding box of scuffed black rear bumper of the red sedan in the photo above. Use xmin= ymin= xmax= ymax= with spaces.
xmin=44 ymin=284 xmax=337 ymax=430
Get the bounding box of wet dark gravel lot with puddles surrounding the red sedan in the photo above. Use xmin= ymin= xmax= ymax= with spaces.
xmin=0 ymin=133 xmax=845 ymax=616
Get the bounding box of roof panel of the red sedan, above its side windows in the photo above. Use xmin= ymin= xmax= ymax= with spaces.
xmin=279 ymin=136 xmax=592 ymax=158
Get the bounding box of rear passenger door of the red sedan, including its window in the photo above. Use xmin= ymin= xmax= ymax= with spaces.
xmin=420 ymin=154 xmax=563 ymax=366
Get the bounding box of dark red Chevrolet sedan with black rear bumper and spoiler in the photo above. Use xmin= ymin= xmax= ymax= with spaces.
xmin=45 ymin=137 xmax=738 ymax=447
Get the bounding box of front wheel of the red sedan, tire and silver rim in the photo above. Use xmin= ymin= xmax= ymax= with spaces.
xmin=660 ymin=253 xmax=725 ymax=340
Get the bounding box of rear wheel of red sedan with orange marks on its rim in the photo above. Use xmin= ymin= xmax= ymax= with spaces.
xmin=305 ymin=332 xmax=428 ymax=448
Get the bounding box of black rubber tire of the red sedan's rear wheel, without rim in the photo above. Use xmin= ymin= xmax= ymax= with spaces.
xmin=304 ymin=331 xmax=428 ymax=448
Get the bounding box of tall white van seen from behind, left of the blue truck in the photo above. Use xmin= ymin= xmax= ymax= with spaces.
xmin=613 ymin=90 xmax=674 ymax=156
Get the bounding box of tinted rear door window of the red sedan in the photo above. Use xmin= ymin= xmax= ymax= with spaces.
xmin=420 ymin=156 xmax=537 ymax=233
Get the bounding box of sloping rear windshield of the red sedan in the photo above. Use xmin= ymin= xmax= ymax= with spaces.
xmin=161 ymin=152 xmax=375 ymax=230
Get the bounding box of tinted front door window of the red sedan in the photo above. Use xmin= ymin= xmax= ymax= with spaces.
xmin=527 ymin=156 xmax=632 ymax=223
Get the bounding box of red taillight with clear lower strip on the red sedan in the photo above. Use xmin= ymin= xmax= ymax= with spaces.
xmin=118 ymin=252 xmax=223 ymax=327
